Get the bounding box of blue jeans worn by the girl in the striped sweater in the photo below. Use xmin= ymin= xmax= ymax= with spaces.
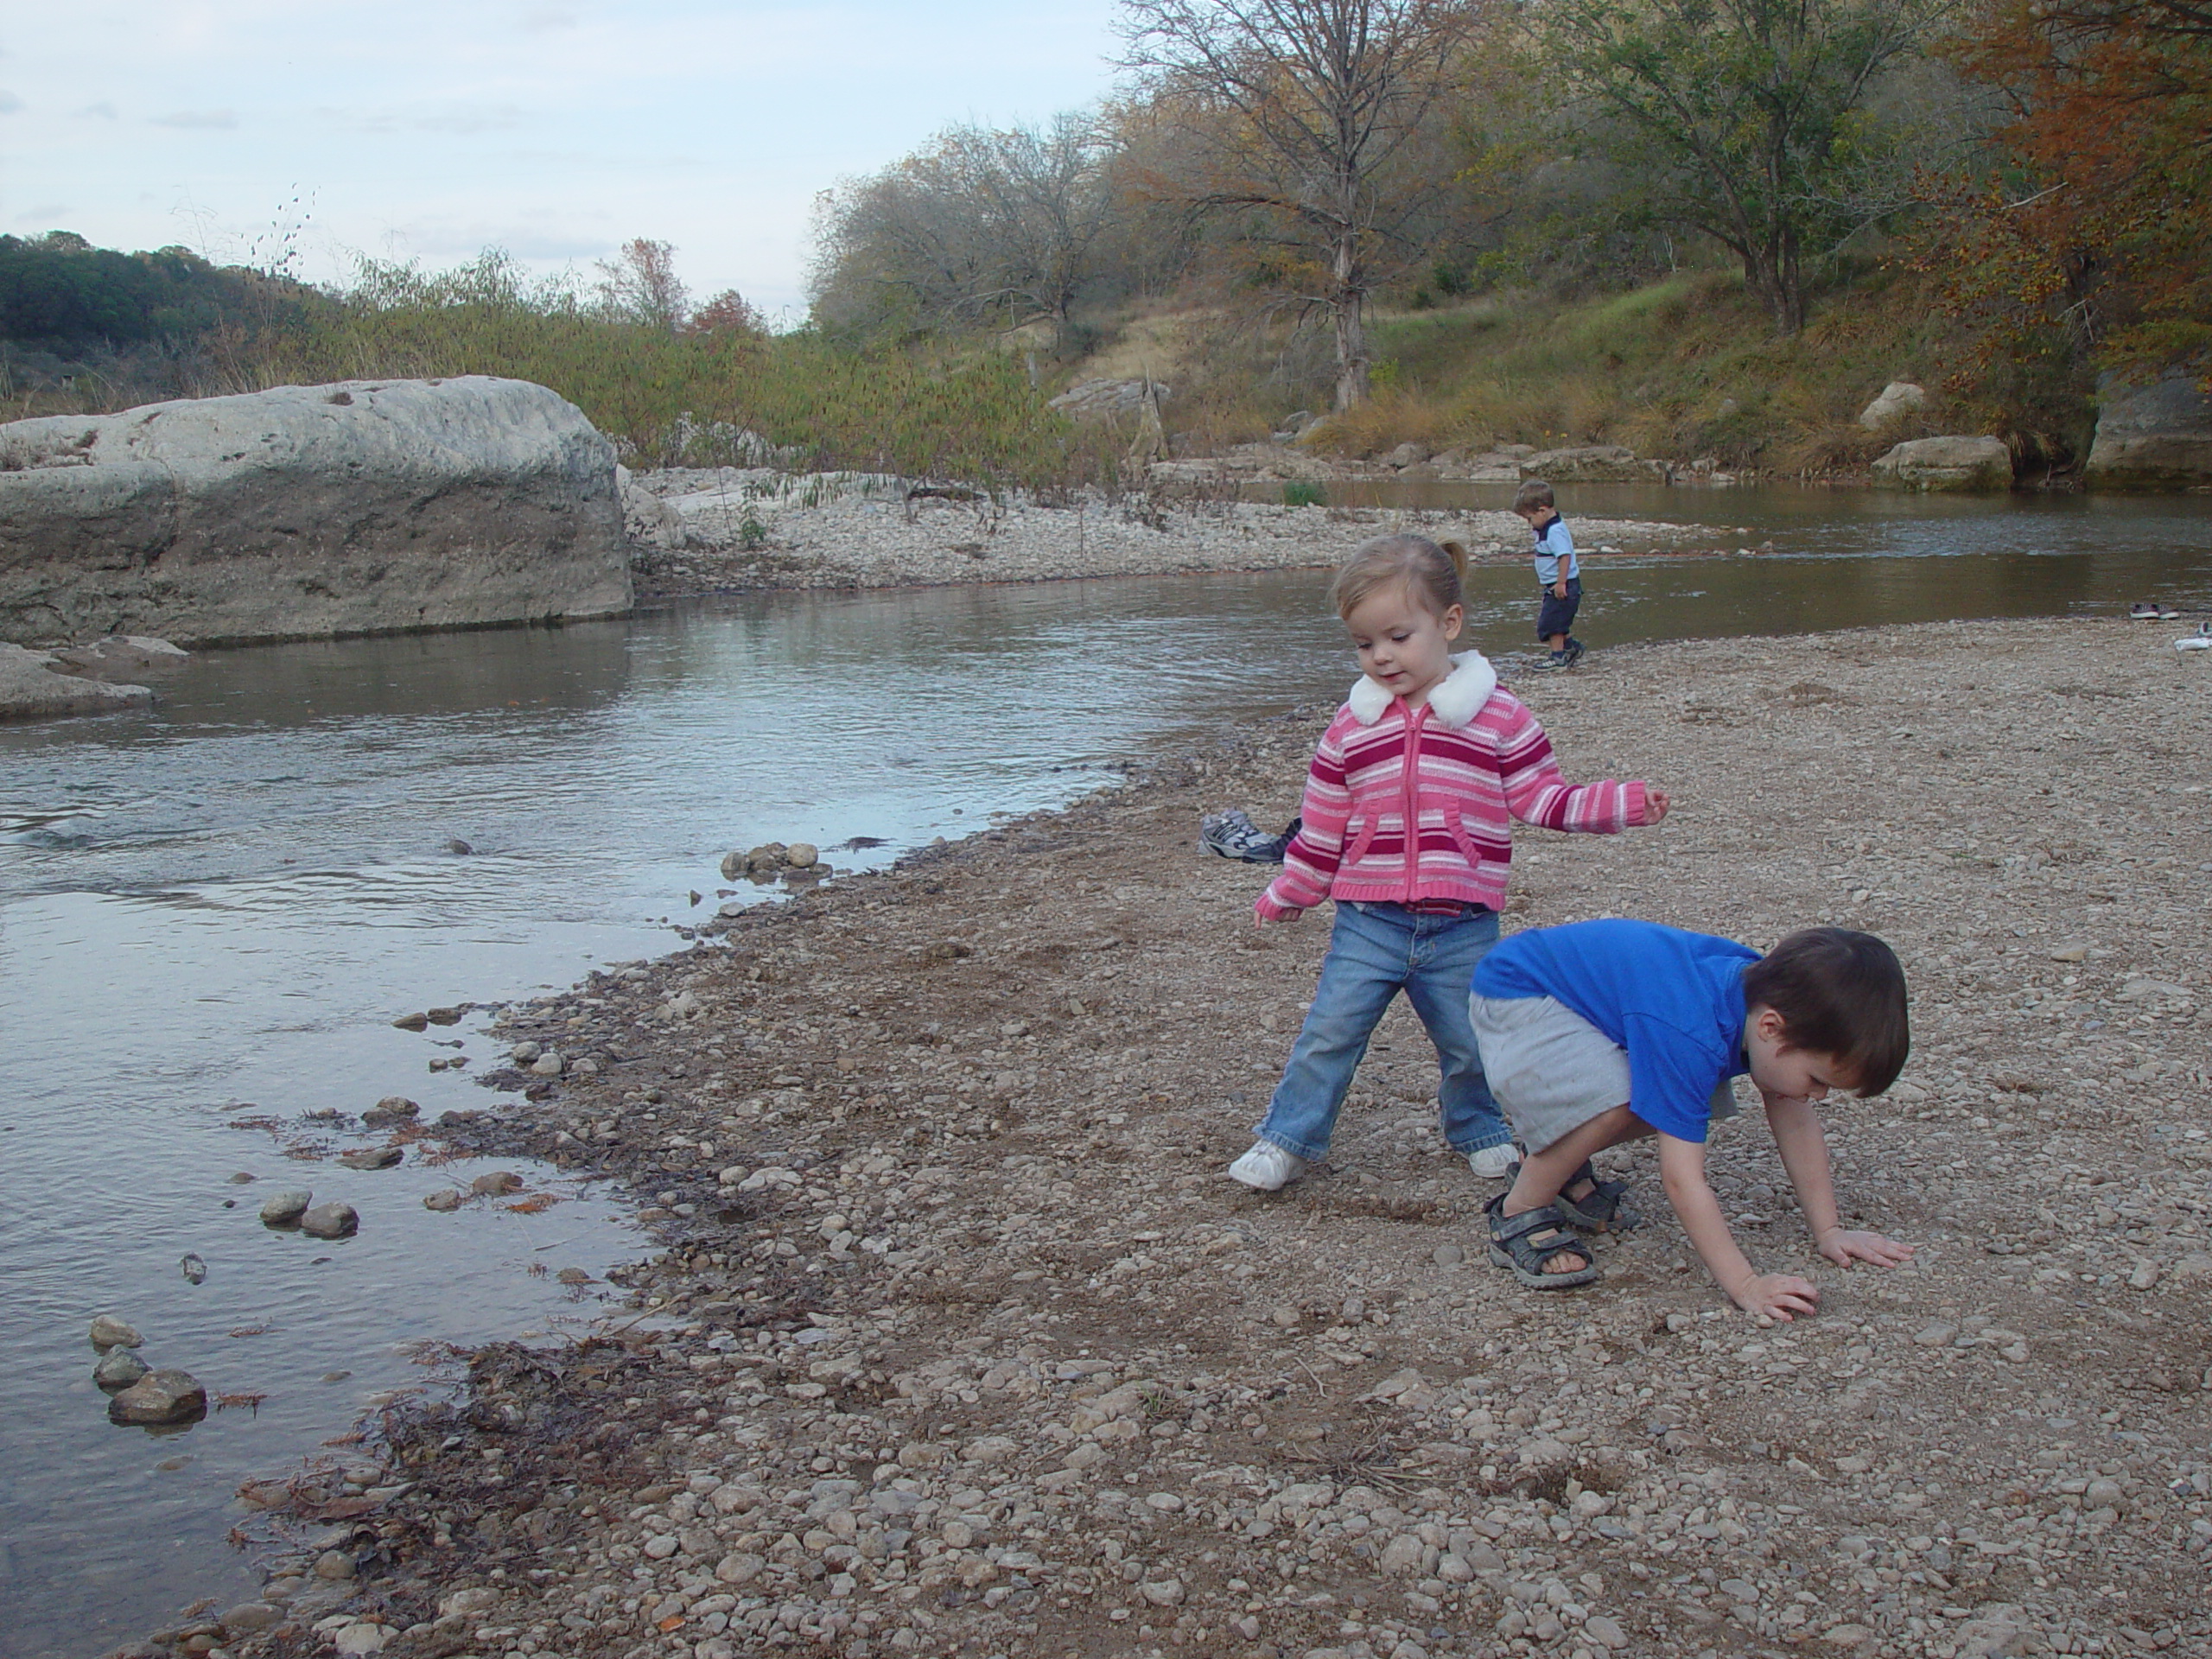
xmin=1255 ymin=905 xmax=1513 ymax=1161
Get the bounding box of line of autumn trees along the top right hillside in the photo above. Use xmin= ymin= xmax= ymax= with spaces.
xmin=812 ymin=0 xmax=2212 ymax=410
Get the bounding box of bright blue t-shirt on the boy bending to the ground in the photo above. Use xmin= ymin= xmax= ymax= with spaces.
xmin=1473 ymin=920 xmax=1758 ymax=1141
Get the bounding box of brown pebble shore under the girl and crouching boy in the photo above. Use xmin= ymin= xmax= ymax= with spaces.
xmin=163 ymin=619 xmax=2212 ymax=1659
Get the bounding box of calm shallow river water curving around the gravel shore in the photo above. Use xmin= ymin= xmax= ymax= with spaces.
xmin=0 ymin=489 xmax=2212 ymax=1659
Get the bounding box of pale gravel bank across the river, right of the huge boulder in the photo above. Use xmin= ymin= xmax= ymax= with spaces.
xmin=631 ymin=469 xmax=1712 ymax=600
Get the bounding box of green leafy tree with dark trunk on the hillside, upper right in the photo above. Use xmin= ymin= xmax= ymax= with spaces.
xmin=1535 ymin=0 xmax=1951 ymax=334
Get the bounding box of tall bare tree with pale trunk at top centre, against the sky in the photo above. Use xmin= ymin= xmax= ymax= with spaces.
xmin=1122 ymin=0 xmax=1482 ymax=410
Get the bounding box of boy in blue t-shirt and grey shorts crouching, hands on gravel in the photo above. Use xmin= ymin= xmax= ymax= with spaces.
xmin=1469 ymin=920 xmax=1913 ymax=1320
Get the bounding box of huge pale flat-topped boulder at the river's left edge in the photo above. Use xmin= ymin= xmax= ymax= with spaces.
xmin=0 ymin=376 xmax=631 ymax=644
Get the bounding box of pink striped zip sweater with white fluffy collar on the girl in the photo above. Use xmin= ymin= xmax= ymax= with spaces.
xmin=1255 ymin=651 xmax=1648 ymax=920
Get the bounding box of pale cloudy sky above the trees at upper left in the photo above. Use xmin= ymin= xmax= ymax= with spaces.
xmin=0 ymin=0 xmax=1117 ymax=321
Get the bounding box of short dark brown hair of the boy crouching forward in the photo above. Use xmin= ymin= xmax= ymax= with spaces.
xmin=1743 ymin=927 xmax=1913 ymax=1095
